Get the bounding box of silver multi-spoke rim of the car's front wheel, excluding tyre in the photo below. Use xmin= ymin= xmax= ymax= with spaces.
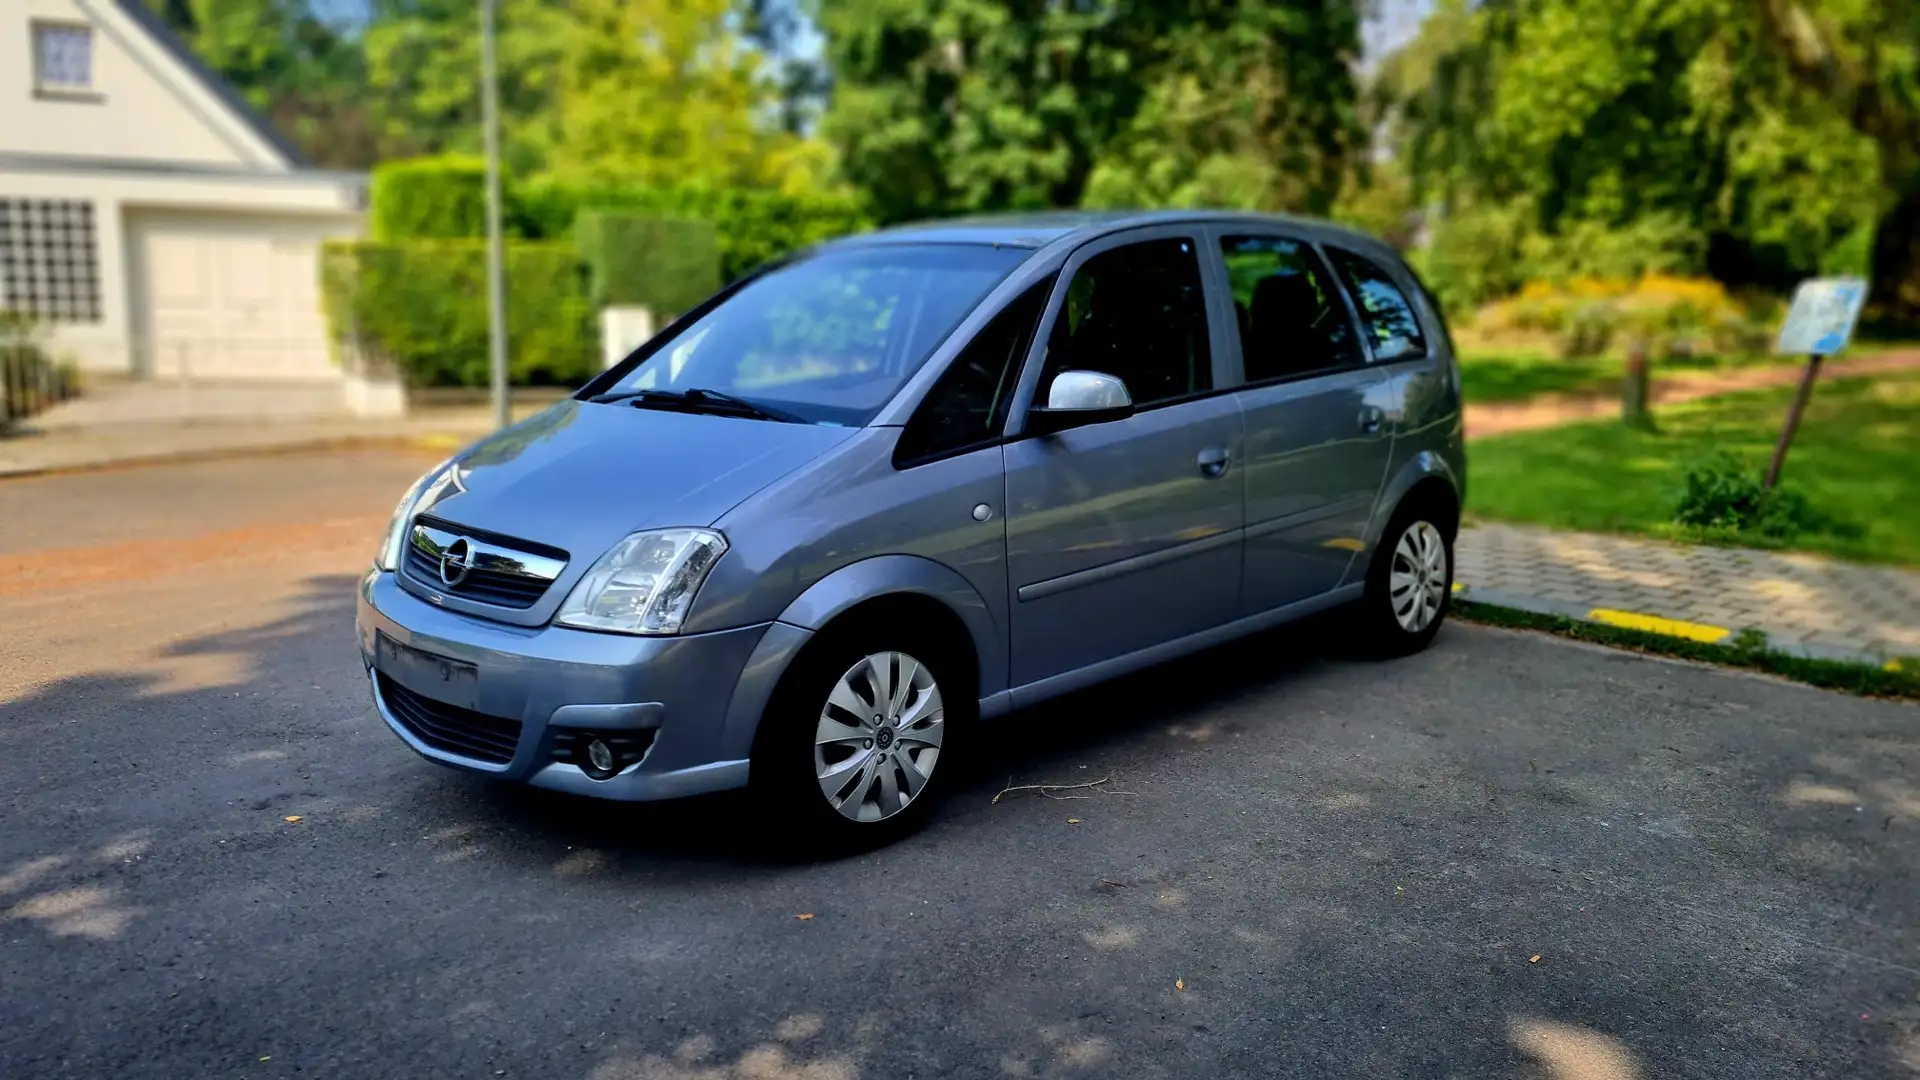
xmin=814 ymin=651 xmax=947 ymax=822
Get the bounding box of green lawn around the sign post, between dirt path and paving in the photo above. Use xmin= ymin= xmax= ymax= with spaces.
xmin=1467 ymin=375 xmax=1920 ymax=565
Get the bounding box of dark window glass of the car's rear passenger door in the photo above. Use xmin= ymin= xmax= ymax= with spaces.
xmin=1219 ymin=236 xmax=1361 ymax=382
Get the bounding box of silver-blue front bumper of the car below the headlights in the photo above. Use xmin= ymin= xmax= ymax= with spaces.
xmin=353 ymin=571 xmax=808 ymax=801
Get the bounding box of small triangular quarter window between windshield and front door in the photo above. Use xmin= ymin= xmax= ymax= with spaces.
xmin=895 ymin=279 xmax=1054 ymax=463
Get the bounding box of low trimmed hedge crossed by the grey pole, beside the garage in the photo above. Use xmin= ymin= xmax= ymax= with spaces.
xmin=321 ymin=240 xmax=599 ymax=386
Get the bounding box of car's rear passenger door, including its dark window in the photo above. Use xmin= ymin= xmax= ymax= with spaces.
xmin=1212 ymin=229 xmax=1394 ymax=615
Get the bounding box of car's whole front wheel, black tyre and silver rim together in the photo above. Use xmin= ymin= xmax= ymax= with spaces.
xmin=751 ymin=625 xmax=960 ymax=853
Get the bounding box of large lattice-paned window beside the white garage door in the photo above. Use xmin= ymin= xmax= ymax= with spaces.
xmin=0 ymin=198 xmax=100 ymax=323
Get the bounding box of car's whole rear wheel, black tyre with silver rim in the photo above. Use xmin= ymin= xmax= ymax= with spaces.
xmin=1354 ymin=490 xmax=1457 ymax=657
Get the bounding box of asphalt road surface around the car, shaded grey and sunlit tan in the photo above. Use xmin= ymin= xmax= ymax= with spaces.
xmin=0 ymin=454 xmax=1920 ymax=1080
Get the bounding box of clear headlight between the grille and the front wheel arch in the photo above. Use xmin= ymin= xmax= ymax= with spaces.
xmin=555 ymin=528 xmax=726 ymax=634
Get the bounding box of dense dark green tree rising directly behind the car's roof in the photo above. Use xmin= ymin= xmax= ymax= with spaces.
xmin=820 ymin=0 xmax=1361 ymax=219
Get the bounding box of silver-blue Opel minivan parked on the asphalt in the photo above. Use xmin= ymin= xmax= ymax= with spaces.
xmin=357 ymin=211 xmax=1467 ymax=840
